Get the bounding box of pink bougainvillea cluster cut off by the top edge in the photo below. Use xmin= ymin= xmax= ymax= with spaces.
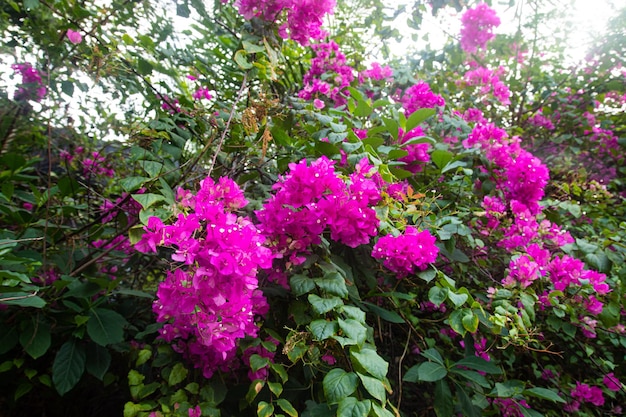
xmin=230 ymin=0 xmax=336 ymax=46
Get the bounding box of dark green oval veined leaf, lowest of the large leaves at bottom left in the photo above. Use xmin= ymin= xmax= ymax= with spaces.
xmin=52 ymin=339 xmax=86 ymax=395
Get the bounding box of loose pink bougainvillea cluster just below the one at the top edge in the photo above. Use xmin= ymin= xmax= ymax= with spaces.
xmin=298 ymin=41 xmax=354 ymax=106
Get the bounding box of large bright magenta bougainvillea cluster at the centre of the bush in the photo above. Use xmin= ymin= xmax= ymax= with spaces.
xmin=256 ymin=157 xmax=381 ymax=287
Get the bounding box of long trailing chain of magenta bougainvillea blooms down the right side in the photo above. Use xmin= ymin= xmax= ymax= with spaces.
xmin=463 ymin=112 xmax=610 ymax=320
